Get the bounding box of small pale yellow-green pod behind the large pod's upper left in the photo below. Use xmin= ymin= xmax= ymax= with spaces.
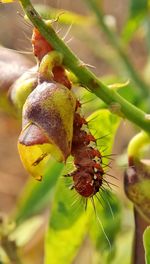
xmin=9 ymin=67 xmax=37 ymax=113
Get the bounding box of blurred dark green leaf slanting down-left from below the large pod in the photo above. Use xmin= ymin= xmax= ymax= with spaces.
xmin=15 ymin=159 xmax=64 ymax=224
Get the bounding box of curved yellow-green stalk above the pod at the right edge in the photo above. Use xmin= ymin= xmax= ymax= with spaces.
xmin=128 ymin=131 xmax=150 ymax=159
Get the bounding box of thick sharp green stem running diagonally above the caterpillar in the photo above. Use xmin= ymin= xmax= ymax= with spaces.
xmin=21 ymin=0 xmax=150 ymax=133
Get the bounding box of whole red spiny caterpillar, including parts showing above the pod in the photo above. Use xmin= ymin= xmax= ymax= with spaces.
xmin=32 ymin=24 xmax=105 ymax=198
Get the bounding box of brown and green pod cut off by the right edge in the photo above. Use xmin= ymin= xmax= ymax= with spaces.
xmin=124 ymin=160 xmax=150 ymax=222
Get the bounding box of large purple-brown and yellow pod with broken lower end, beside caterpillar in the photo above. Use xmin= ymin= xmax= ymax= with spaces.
xmin=18 ymin=82 xmax=76 ymax=179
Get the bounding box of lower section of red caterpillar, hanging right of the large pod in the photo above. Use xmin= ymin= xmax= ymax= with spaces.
xmin=67 ymin=102 xmax=104 ymax=198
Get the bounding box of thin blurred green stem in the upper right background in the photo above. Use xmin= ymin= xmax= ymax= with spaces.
xmin=86 ymin=0 xmax=150 ymax=97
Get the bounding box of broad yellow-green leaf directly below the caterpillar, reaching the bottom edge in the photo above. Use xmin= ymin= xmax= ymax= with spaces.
xmin=44 ymin=165 xmax=89 ymax=264
